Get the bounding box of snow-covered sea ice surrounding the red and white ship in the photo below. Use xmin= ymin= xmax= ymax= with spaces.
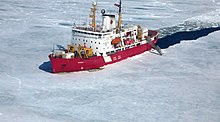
xmin=0 ymin=0 xmax=220 ymax=122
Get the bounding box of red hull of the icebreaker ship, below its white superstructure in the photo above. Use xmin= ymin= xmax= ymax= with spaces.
xmin=49 ymin=39 xmax=157 ymax=73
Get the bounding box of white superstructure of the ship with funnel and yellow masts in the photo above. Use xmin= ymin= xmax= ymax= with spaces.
xmin=72 ymin=3 xmax=148 ymax=55
